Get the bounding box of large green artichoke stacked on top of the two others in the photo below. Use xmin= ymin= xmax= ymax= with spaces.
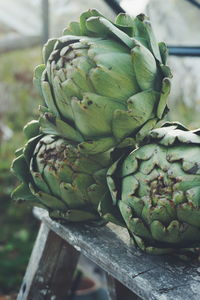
xmin=34 ymin=9 xmax=172 ymax=154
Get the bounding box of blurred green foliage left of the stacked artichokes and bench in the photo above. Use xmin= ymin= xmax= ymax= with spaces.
xmin=0 ymin=47 xmax=42 ymax=294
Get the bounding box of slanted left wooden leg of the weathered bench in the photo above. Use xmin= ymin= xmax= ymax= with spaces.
xmin=17 ymin=223 xmax=79 ymax=300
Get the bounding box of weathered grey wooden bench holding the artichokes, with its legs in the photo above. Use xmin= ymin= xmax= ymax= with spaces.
xmin=18 ymin=208 xmax=200 ymax=300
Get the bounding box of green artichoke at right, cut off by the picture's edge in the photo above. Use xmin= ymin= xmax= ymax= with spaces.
xmin=108 ymin=123 xmax=200 ymax=256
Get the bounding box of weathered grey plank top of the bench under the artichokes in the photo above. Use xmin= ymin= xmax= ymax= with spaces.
xmin=34 ymin=208 xmax=200 ymax=300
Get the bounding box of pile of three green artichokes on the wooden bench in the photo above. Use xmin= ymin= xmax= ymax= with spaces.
xmin=12 ymin=9 xmax=200 ymax=254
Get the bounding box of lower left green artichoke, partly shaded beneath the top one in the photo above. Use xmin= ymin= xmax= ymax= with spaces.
xmin=12 ymin=121 xmax=115 ymax=223
